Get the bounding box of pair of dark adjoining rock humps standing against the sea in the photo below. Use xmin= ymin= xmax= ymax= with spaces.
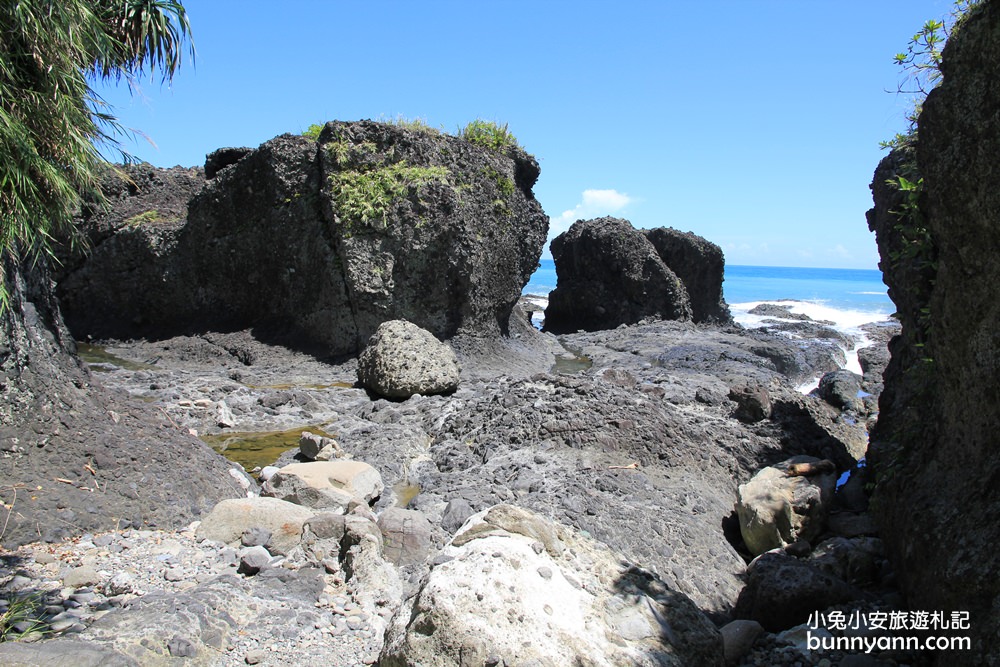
xmin=545 ymin=218 xmax=731 ymax=333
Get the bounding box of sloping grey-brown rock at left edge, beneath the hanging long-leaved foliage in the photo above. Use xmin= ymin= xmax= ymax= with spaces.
xmin=0 ymin=258 xmax=246 ymax=547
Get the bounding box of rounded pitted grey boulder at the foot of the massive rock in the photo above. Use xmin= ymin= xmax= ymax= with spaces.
xmin=358 ymin=320 xmax=460 ymax=399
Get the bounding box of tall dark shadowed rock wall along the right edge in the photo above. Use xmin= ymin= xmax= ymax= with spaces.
xmin=869 ymin=3 xmax=1000 ymax=664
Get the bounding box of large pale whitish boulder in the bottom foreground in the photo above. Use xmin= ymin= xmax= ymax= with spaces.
xmin=380 ymin=505 xmax=724 ymax=667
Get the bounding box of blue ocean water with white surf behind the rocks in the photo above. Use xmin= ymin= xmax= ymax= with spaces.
xmin=523 ymin=259 xmax=896 ymax=384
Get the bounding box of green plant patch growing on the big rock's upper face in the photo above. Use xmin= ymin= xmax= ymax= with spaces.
xmin=326 ymin=140 xmax=451 ymax=230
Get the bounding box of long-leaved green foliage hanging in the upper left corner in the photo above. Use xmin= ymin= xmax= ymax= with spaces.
xmin=0 ymin=0 xmax=193 ymax=310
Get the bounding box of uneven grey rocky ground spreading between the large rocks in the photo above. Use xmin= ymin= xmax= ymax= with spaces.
xmin=0 ymin=320 xmax=911 ymax=665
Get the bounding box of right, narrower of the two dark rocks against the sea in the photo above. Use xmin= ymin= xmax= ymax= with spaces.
xmin=642 ymin=227 xmax=733 ymax=324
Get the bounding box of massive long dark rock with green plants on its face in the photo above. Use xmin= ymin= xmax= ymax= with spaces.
xmin=59 ymin=121 xmax=548 ymax=354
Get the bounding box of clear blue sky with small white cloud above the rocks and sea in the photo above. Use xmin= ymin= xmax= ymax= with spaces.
xmin=97 ymin=0 xmax=951 ymax=269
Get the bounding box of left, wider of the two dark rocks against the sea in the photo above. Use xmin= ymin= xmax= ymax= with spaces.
xmin=545 ymin=218 xmax=692 ymax=333
